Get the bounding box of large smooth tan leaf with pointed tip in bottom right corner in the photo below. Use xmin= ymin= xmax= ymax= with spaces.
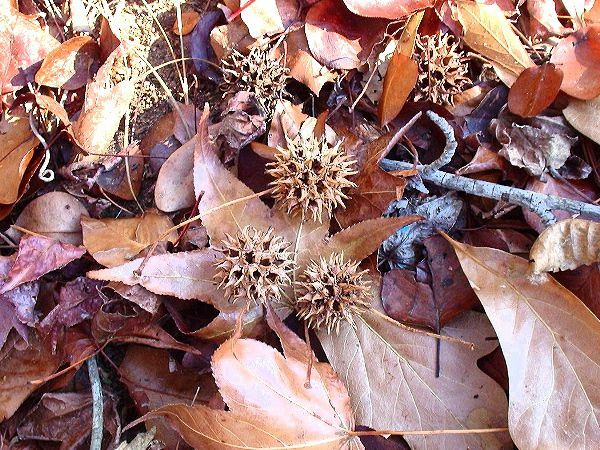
xmin=451 ymin=237 xmax=600 ymax=450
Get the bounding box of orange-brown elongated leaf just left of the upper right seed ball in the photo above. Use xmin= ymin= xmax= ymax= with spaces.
xmin=377 ymin=53 xmax=419 ymax=126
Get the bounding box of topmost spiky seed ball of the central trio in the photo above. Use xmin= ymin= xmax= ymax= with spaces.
xmin=267 ymin=135 xmax=357 ymax=222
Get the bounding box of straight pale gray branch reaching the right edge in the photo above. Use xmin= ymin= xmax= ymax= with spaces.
xmin=380 ymin=159 xmax=600 ymax=223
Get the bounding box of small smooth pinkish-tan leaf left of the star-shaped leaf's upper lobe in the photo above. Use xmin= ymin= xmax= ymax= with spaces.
xmin=154 ymin=139 xmax=196 ymax=212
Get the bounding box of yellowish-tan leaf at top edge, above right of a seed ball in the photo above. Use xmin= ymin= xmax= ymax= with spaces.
xmin=456 ymin=0 xmax=534 ymax=84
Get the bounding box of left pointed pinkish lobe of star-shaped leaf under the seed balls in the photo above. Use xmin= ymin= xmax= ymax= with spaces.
xmin=87 ymin=248 xmax=235 ymax=311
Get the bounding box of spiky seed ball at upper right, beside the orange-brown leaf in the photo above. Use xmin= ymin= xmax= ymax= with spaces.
xmin=415 ymin=32 xmax=471 ymax=105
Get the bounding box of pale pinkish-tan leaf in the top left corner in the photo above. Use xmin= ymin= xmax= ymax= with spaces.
xmin=0 ymin=5 xmax=59 ymax=95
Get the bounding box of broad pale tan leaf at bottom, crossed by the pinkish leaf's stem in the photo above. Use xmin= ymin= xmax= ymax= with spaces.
xmin=318 ymin=279 xmax=509 ymax=449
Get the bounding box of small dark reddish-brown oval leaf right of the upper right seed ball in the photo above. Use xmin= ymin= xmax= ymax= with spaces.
xmin=508 ymin=63 xmax=563 ymax=117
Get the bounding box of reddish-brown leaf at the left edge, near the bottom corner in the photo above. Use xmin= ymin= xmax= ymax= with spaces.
xmin=0 ymin=333 xmax=61 ymax=421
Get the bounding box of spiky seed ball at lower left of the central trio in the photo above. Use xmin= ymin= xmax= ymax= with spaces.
xmin=215 ymin=225 xmax=294 ymax=304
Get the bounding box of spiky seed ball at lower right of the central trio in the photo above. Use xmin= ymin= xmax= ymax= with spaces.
xmin=295 ymin=253 xmax=370 ymax=333
